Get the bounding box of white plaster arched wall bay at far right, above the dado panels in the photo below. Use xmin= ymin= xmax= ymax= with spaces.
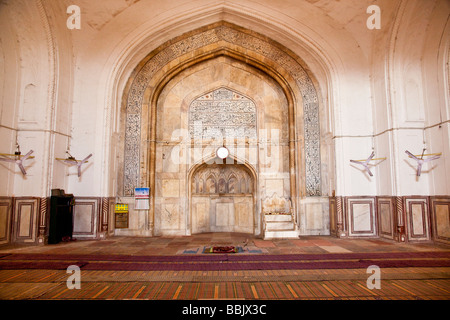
xmin=374 ymin=1 xmax=449 ymax=195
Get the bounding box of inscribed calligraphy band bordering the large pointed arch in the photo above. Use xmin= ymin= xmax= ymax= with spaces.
xmin=123 ymin=23 xmax=321 ymax=196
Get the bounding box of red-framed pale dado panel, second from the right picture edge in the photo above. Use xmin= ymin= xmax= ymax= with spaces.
xmin=405 ymin=197 xmax=430 ymax=241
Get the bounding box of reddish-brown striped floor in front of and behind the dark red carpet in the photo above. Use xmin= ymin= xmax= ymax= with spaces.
xmin=0 ymin=233 xmax=450 ymax=300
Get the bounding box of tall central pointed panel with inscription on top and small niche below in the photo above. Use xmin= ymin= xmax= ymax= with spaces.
xmin=188 ymin=87 xmax=256 ymax=234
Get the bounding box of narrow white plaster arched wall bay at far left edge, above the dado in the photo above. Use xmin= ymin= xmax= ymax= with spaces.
xmin=0 ymin=1 xmax=50 ymax=196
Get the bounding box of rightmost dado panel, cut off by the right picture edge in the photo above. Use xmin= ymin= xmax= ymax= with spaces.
xmin=430 ymin=197 xmax=450 ymax=244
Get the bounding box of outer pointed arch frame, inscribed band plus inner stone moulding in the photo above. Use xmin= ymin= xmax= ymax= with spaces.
xmin=122 ymin=22 xmax=322 ymax=235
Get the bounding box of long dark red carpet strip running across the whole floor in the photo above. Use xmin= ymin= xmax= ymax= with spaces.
xmin=0 ymin=252 xmax=450 ymax=271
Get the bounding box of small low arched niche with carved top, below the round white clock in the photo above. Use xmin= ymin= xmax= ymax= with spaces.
xmin=187 ymin=155 xmax=256 ymax=235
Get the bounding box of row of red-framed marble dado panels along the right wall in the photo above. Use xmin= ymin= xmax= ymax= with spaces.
xmin=329 ymin=196 xmax=450 ymax=244
